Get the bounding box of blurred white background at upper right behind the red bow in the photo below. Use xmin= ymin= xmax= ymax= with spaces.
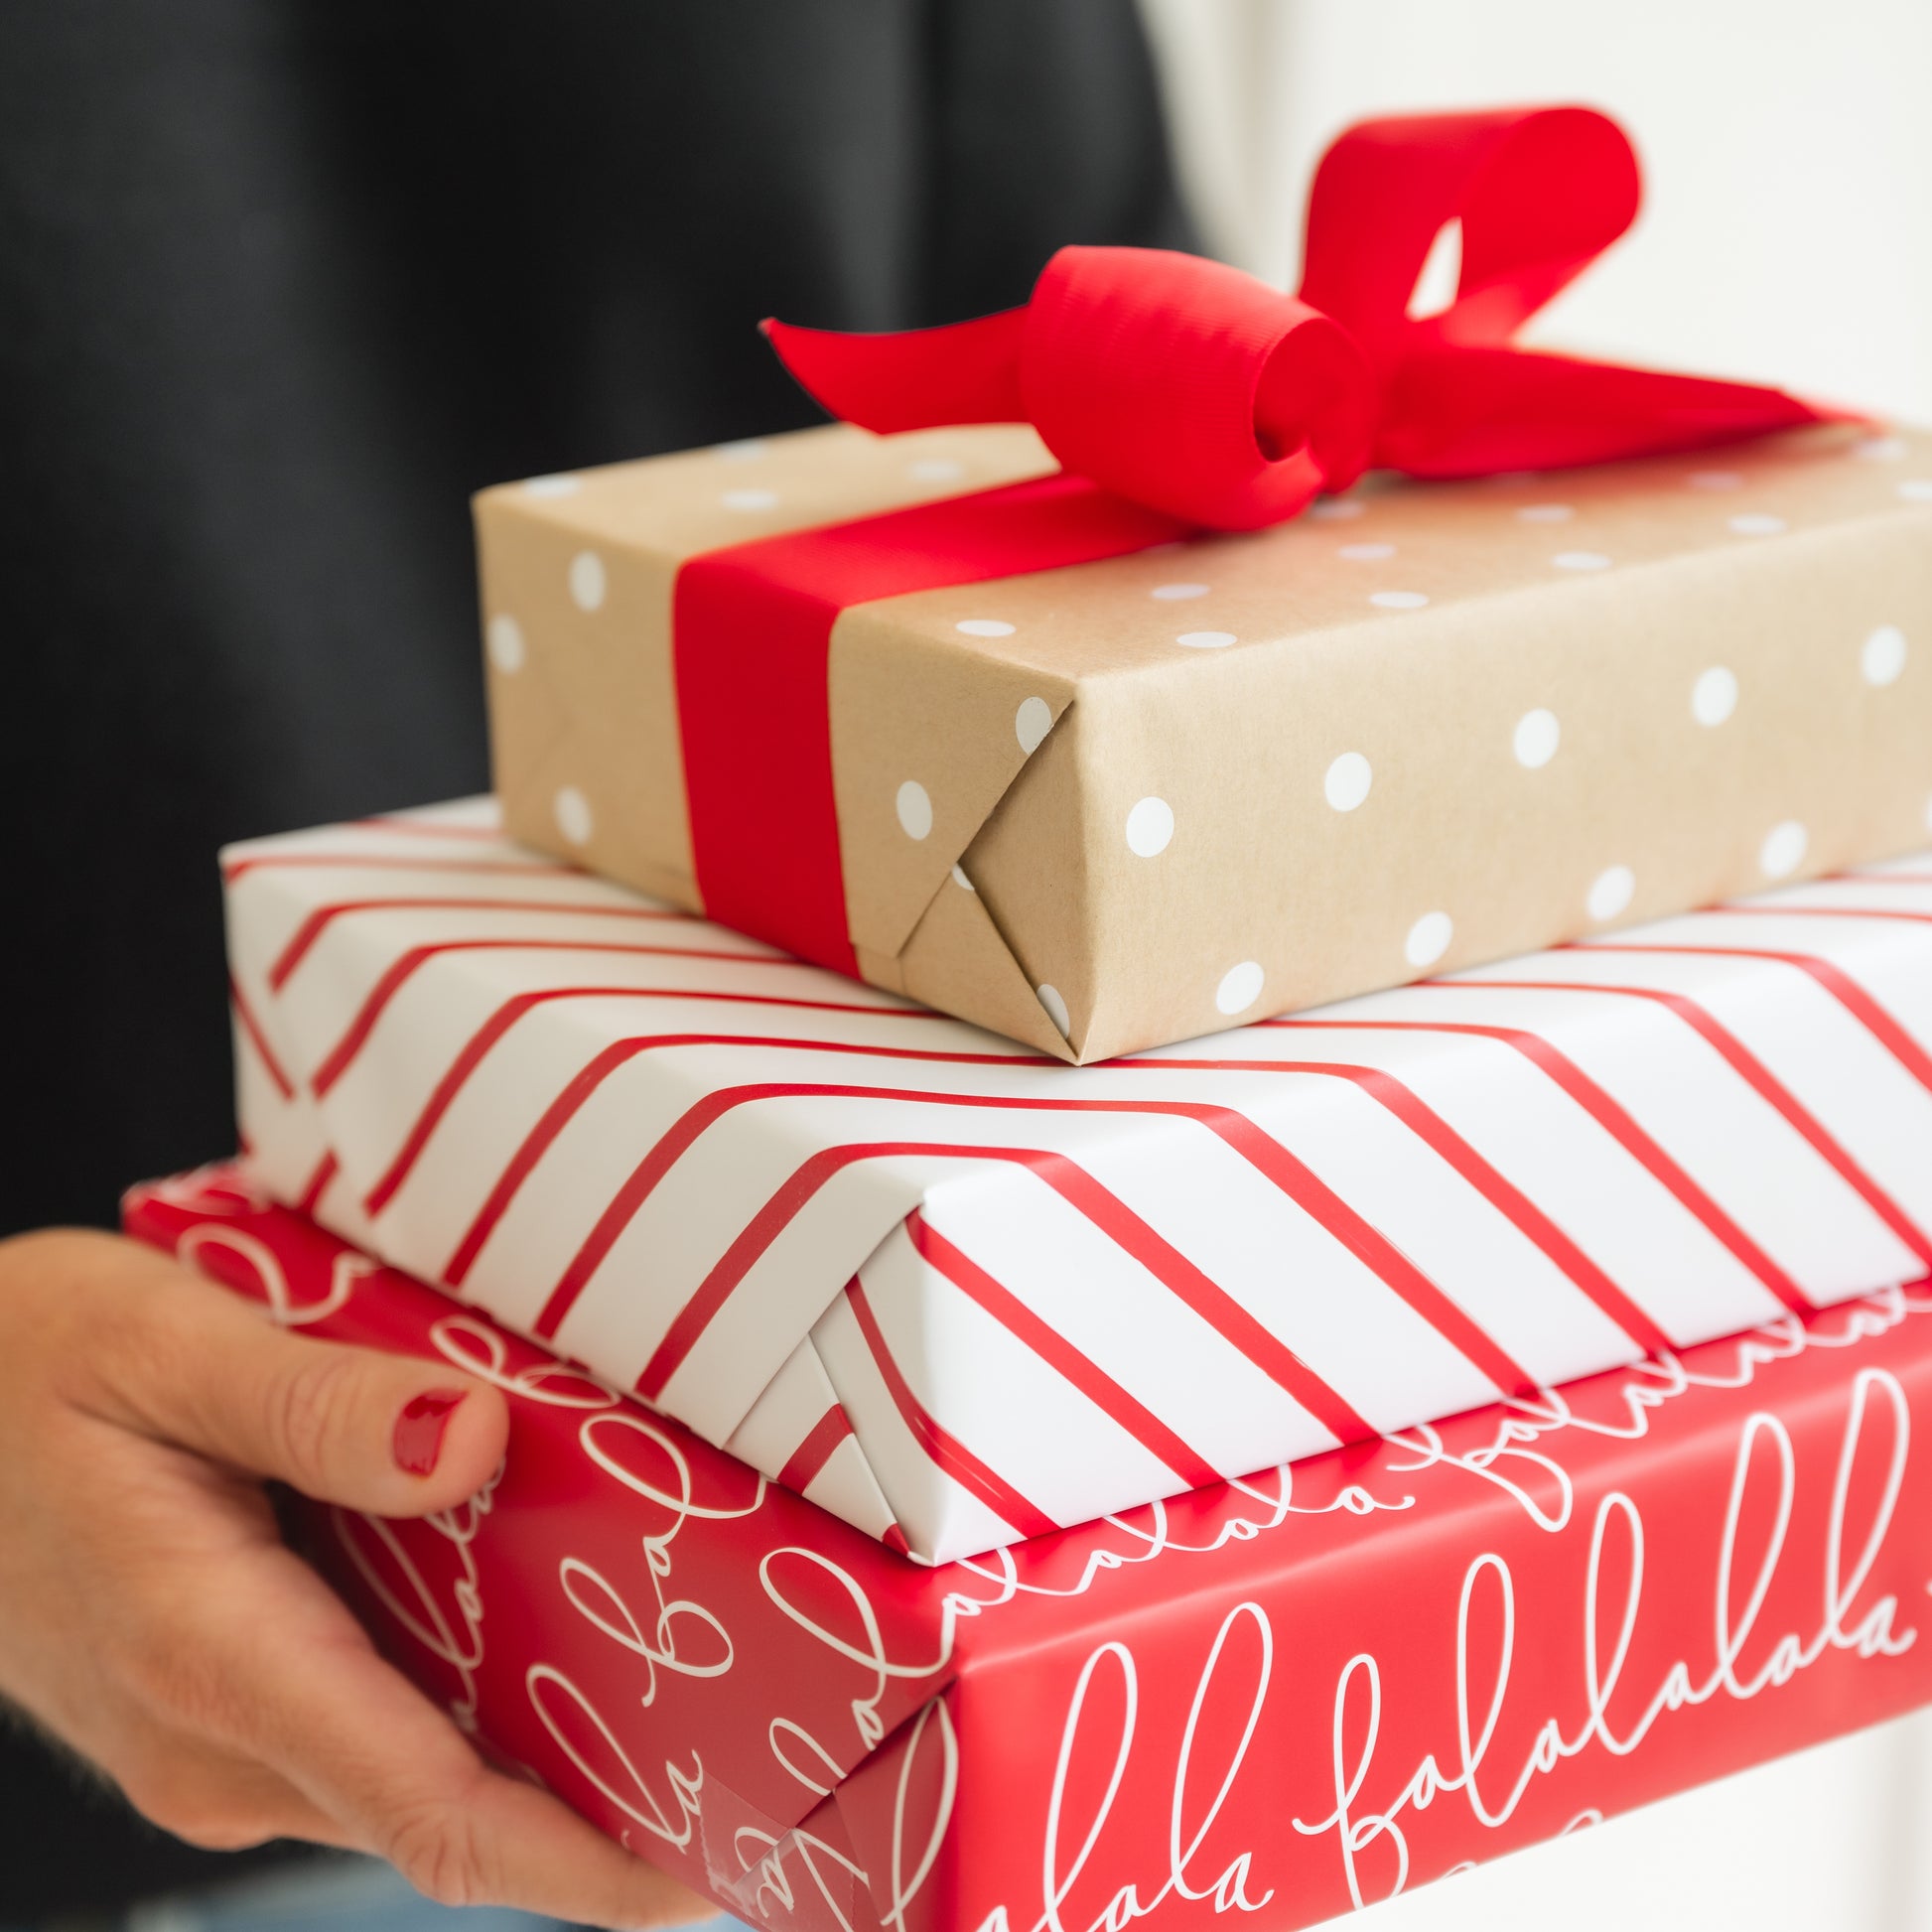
xmin=1144 ymin=0 xmax=1932 ymax=423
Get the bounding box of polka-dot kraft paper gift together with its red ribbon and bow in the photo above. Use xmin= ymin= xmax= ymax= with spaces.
xmin=476 ymin=106 xmax=1932 ymax=1062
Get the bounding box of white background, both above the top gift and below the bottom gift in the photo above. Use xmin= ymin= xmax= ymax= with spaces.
xmin=1142 ymin=0 xmax=1932 ymax=1932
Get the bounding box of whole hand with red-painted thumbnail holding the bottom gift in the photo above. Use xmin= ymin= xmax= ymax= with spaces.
xmin=0 ymin=1231 xmax=713 ymax=1926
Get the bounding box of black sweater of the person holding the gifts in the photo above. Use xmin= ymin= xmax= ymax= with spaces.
xmin=0 ymin=0 xmax=1188 ymax=1922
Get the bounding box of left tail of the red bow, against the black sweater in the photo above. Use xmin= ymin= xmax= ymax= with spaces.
xmin=763 ymin=309 xmax=1026 ymax=435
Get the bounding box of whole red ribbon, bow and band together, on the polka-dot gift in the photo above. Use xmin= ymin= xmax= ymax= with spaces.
xmin=674 ymin=108 xmax=1828 ymax=972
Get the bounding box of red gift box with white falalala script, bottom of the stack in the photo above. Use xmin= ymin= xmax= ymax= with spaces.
xmin=127 ymin=1173 xmax=1932 ymax=1932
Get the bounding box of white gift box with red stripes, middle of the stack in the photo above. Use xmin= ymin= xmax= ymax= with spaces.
xmin=224 ymin=802 xmax=1932 ymax=1561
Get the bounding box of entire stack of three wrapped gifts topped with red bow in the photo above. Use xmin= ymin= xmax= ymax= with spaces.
xmin=127 ymin=110 xmax=1932 ymax=1932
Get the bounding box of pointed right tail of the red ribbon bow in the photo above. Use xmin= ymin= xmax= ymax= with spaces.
xmin=1376 ymin=344 xmax=1857 ymax=478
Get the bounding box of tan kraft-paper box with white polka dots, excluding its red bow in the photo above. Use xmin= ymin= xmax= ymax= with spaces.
xmin=478 ymin=425 xmax=1932 ymax=1060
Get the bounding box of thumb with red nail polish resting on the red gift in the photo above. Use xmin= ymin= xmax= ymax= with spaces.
xmin=81 ymin=1238 xmax=510 ymax=1517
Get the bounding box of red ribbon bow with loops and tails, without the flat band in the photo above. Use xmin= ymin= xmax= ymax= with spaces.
xmin=765 ymin=108 xmax=1826 ymax=529
